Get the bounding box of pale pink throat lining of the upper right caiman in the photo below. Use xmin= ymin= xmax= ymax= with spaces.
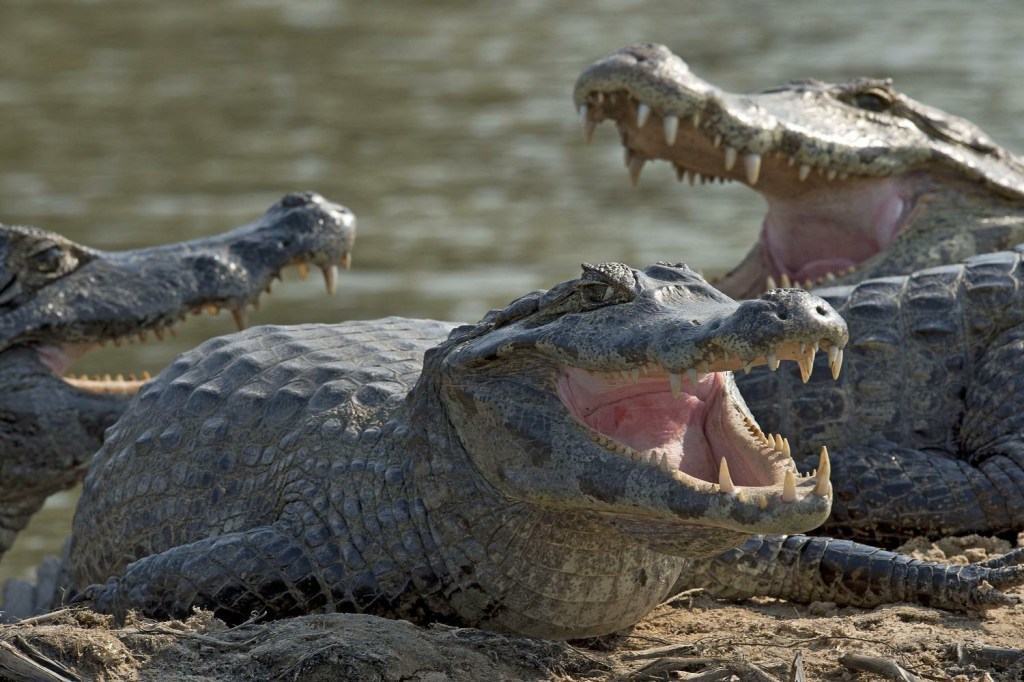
xmin=761 ymin=179 xmax=910 ymax=282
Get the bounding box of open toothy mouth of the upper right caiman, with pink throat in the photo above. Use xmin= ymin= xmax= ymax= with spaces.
xmin=580 ymin=90 xmax=930 ymax=298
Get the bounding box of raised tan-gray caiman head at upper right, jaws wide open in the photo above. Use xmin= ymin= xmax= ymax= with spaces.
xmin=573 ymin=44 xmax=1024 ymax=298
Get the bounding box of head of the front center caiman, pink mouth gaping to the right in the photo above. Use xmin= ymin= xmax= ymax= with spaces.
xmin=419 ymin=258 xmax=847 ymax=556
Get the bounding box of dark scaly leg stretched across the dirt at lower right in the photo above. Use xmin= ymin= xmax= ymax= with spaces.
xmin=676 ymin=536 xmax=1024 ymax=611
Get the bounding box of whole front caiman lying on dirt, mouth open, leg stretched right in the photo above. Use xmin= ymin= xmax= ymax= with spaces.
xmin=61 ymin=263 xmax=1024 ymax=639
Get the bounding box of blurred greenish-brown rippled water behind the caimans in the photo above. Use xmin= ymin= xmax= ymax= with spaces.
xmin=0 ymin=0 xmax=1024 ymax=578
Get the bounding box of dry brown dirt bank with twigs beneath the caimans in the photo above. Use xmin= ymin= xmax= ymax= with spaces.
xmin=0 ymin=538 xmax=1024 ymax=682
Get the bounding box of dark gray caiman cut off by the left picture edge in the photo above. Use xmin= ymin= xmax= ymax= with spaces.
xmin=0 ymin=193 xmax=355 ymax=555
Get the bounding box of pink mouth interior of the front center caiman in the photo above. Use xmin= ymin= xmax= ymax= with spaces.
xmin=558 ymin=369 xmax=765 ymax=485
